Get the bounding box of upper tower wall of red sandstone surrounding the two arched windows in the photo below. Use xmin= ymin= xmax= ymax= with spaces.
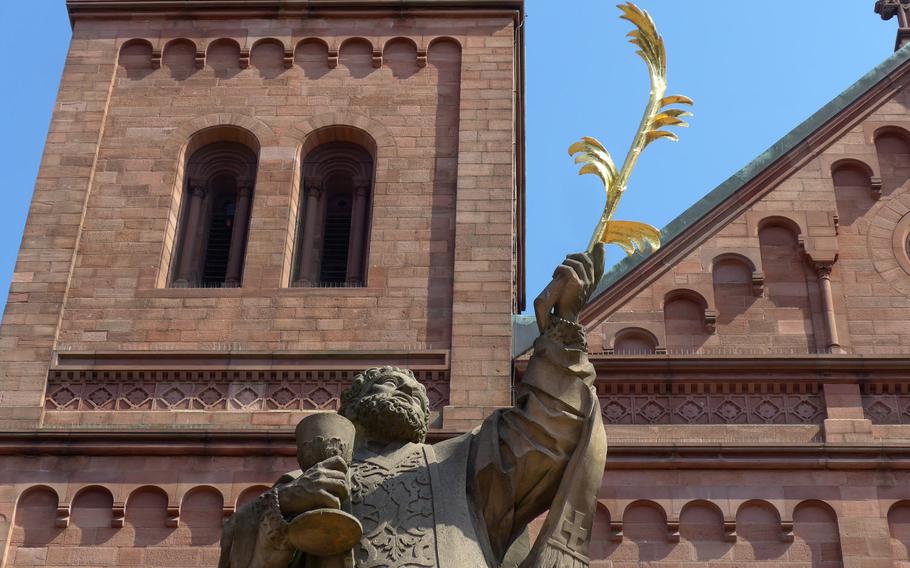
xmin=0 ymin=11 xmax=515 ymax=427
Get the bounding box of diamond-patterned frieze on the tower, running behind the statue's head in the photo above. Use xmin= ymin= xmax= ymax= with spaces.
xmin=45 ymin=370 xmax=449 ymax=412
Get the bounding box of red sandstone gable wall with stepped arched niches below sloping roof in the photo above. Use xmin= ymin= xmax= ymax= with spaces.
xmin=591 ymin=72 xmax=910 ymax=356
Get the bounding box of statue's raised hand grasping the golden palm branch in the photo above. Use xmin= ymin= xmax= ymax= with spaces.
xmin=534 ymin=244 xmax=604 ymax=333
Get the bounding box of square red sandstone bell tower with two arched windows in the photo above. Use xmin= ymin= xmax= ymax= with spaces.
xmin=0 ymin=0 xmax=524 ymax=565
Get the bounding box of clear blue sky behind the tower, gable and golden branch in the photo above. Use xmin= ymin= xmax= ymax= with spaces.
xmin=0 ymin=0 xmax=896 ymax=316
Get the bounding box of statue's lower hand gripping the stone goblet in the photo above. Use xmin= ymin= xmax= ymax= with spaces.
xmin=278 ymin=456 xmax=350 ymax=515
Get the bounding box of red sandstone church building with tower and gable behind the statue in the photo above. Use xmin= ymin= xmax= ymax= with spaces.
xmin=0 ymin=0 xmax=910 ymax=568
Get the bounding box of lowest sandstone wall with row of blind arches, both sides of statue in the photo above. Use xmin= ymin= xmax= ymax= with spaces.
xmin=0 ymin=457 xmax=910 ymax=568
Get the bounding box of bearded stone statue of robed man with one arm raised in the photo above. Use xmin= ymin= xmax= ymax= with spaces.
xmin=219 ymin=245 xmax=607 ymax=568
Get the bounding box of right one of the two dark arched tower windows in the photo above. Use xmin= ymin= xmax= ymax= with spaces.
xmin=294 ymin=140 xmax=373 ymax=287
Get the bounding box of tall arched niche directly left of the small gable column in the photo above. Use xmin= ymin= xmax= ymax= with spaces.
xmin=758 ymin=217 xmax=815 ymax=353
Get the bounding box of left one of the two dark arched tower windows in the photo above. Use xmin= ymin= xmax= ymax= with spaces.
xmin=171 ymin=141 xmax=257 ymax=288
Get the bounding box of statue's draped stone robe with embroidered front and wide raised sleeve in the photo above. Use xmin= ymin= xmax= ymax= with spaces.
xmin=220 ymin=336 xmax=606 ymax=568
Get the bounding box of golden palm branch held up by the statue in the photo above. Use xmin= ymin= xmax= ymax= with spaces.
xmin=569 ymin=2 xmax=692 ymax=255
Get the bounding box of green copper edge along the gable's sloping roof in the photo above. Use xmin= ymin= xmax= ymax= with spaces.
xmin=512 ymin=44 xmax=910 ymax=359
